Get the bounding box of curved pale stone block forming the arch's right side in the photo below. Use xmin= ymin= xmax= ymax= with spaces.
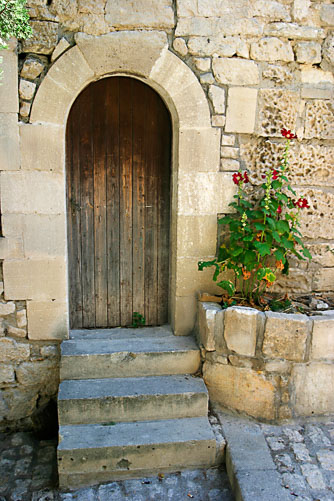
xmin=149 ymin=50 xmax=211 ymax=128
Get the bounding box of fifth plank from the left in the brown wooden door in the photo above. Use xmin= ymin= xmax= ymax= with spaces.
xmin=119 ymin=77 xmax=133 ymax=325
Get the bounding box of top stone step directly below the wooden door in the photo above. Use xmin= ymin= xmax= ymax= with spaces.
xmin=60 ymin=328 xmax=200 ymax=380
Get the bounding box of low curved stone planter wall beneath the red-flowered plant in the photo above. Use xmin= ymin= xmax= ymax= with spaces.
xmin=197 ymin=302 xmax=334 ymax=422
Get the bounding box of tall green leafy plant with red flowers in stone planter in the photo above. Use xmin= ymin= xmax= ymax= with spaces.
xmin=198 ymin=129 xmax=311 ymax=303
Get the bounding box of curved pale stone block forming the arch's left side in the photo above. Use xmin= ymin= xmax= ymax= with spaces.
xmin=30 ymin=47 xmax=94 ymax=125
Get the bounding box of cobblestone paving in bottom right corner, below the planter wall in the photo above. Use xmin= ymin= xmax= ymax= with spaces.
xmin=261 ymin=419 xmax=334 ymax=501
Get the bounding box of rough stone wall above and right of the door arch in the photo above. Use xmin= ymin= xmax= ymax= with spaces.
xmin=15 ymin=0 xmax=334 ymax=292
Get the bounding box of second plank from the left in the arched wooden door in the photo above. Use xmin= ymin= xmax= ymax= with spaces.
xmin=77 ymin=86 xmax=95 ymax=327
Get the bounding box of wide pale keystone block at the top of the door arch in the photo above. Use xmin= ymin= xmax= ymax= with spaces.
xmin=75 ymin=31 xmax=168 ymax=78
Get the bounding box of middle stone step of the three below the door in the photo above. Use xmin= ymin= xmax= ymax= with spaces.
xmin=58 ymin=375 xmax=208 ymax=424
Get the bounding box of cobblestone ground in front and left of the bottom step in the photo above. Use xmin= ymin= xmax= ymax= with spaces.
xmin=0 ymin=433 xmax=234 ymax=501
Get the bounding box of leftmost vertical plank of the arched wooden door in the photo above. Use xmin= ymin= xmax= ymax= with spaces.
xmin=66 ymin=97 xmax=82 ymax=329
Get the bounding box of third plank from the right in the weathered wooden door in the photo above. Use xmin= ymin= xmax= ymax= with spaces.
xmin=132 ymin=82 xmax=147 ymax=316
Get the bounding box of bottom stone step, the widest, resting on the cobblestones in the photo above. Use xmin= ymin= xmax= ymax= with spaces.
xmin=58 ymin=417 xmax=216 ymax=488
